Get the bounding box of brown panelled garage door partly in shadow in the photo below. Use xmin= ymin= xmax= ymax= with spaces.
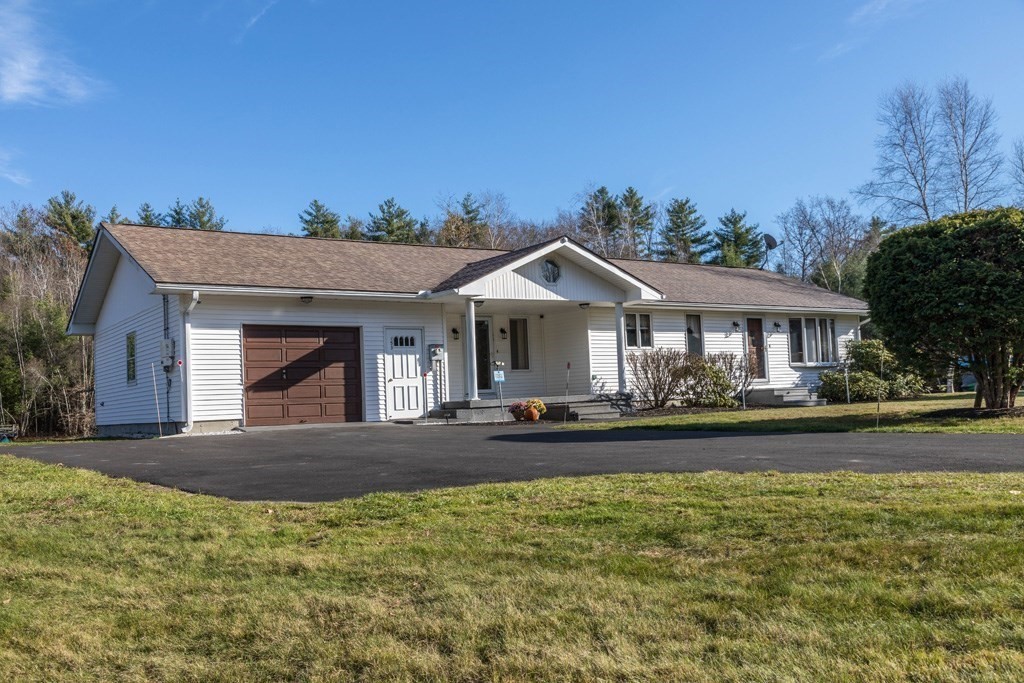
xmin=242 ymin=325 xmax=362 ymax=425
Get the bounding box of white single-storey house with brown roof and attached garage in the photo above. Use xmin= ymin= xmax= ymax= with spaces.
xmin=69 ymin=223 xmax=867 ymax=434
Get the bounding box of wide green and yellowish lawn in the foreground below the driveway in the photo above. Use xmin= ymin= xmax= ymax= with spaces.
xmin=0 ymin=456 xmax=1024 ymax=681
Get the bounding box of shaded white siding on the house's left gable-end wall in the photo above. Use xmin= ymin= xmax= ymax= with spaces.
xmin=93 ymin=257 xmax=182 ymax=426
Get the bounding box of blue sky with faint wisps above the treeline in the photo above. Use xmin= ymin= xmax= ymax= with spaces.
xmin=0 ymin=0 xmax=1024 ymax=237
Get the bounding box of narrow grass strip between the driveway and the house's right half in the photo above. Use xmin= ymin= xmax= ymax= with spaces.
xmin=566 ymin=393 xmax=1024 ymax=434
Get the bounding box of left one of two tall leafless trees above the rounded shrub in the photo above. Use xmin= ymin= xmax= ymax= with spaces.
xmin=856 ymin=82 xmax=942 ymax=224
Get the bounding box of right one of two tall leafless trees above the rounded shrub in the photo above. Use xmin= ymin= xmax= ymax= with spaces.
xmin=938 ymin=78 xmax=1004 ymax=212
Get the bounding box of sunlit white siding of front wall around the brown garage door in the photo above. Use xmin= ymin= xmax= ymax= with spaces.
xmin=191 ymin=294 xmax=451 ymax=422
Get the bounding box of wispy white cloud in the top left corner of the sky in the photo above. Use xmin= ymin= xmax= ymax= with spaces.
xmin=0 ymin=0 xmax=102 ymax=104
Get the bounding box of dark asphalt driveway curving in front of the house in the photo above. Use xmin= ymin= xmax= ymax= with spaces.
xmin=8 ymin=424 xmax=1024 ymax=501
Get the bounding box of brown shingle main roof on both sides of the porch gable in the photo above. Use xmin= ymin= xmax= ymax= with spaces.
xmin=105 ymin=225 xmax=867 ymax=311
